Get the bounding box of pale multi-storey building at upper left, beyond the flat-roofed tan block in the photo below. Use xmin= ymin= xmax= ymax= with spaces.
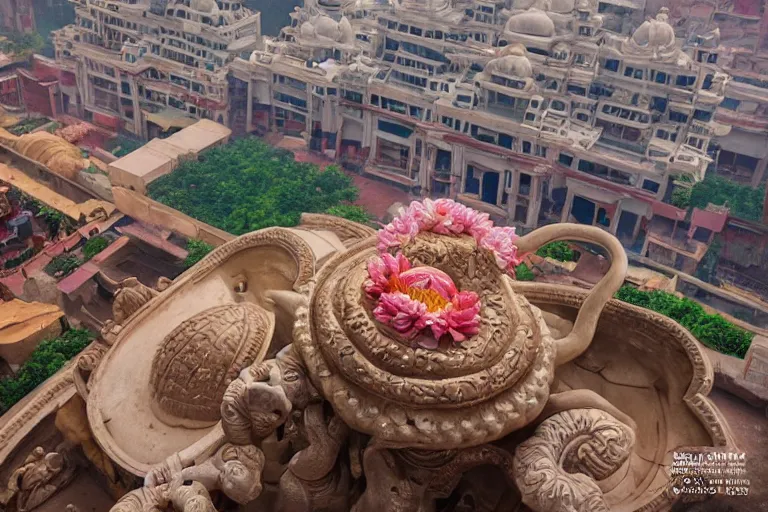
xmin=48 ymin=0 xmax=261 ymax=138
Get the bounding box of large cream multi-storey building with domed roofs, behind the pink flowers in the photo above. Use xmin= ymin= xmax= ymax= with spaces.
xmin=230 ymin=0 xmax=729 ymax=254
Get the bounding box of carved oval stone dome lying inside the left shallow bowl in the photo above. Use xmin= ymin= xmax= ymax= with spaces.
xmin=150 ymin=302 xmax=275 ymax=428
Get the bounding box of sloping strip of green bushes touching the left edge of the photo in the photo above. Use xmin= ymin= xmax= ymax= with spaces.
xmin=0 ymin=329 xmax=93 ymax=414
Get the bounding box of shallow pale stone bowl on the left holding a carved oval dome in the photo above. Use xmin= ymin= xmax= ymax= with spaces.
xmin=87 ymin=228 xmax=315 ymax=476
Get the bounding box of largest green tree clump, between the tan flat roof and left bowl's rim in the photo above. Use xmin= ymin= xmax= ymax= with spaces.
xmin=149 ymin=138 xmax=358 ymax=235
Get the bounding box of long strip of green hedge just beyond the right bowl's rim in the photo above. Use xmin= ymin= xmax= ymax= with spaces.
xmin=616 ymin=286 xmax=754 ymax=359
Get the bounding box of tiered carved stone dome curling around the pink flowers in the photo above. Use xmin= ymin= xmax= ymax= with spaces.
xmin=295 ymin=233 xmax=554 ymax=449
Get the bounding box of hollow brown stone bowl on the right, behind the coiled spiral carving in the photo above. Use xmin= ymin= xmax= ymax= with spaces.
xmin=513 ymin=282 xmax=736 ymax=511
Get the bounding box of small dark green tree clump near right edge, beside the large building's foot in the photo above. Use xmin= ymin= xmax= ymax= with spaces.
xmin=688 ymin=176 xmax=765 ymax=221
